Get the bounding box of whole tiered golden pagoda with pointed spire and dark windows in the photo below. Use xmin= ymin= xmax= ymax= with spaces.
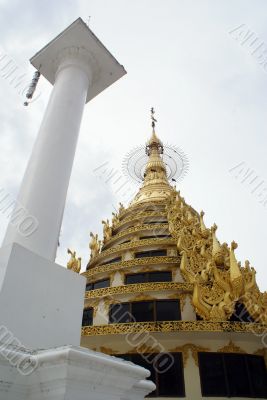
xmin=77 ymin=114 xmax=267 ymax=400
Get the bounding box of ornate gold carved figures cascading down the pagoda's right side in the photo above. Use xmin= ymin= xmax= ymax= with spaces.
xmin=166 ymin=188 xmax=267 ymax=325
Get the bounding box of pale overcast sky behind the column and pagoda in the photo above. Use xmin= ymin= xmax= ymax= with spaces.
xmin=0 ymin=0 xmax=267 ymax=290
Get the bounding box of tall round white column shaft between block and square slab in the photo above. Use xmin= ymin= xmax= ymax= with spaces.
xmin=3 ymin=47 xmax=92 ymax=261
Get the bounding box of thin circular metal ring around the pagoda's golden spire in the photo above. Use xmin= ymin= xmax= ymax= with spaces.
xmin=122 ymin=144 xmax=189 ymax=184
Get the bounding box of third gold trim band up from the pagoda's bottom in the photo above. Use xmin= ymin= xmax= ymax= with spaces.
xmin=84 ymin=256 xmax=180 ymax=278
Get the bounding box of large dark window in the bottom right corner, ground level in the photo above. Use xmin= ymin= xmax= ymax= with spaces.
xmin=198 ymin=353 xmax=267 ymax=399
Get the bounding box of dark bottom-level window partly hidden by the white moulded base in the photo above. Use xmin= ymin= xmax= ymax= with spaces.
xmin=117 ymin=353 xmax=185 ymax=397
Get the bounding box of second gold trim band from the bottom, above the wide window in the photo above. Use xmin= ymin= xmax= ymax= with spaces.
xmin=85 ymin=282 xmax=193 ymax=299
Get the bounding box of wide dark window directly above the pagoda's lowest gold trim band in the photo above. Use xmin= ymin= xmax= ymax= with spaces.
xmin=109 ymin=300 xmax=181 ymax=323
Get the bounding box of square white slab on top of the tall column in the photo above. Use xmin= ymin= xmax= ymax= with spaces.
xmin=31 ymin=18 xmax=126 ymax=102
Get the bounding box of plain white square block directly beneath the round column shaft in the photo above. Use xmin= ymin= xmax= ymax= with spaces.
xmin=0 ymin=243 xmax=86 ymax=348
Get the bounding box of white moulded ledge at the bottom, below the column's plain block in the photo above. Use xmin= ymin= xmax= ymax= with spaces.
xmin=0 ymin=346 xmax=155 ymax=400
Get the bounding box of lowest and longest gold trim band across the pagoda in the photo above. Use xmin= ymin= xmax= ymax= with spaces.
xmin=82 ymin=321 xmax=266 ymax=336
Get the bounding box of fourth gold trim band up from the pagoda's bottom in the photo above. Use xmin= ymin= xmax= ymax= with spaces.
xmin=89 ymin=238 xmax=176 ymax=266
